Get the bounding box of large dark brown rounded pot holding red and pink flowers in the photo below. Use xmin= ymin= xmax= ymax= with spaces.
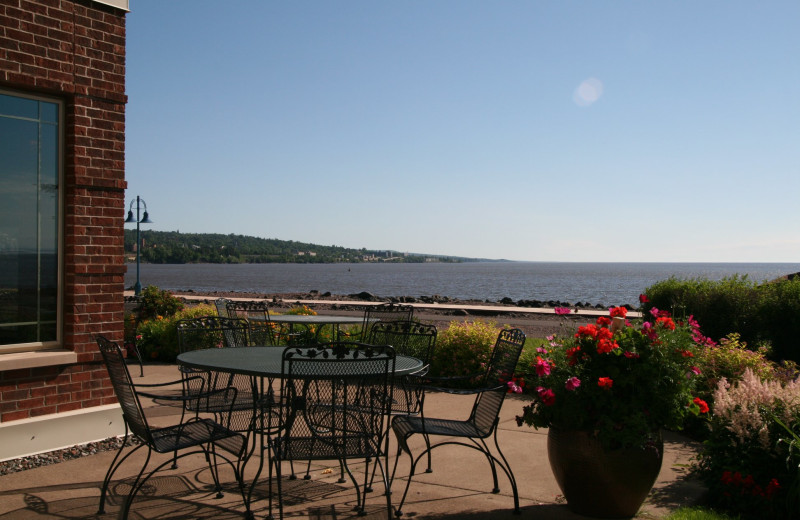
xmin=547 ymin=428 xmax=664 ymax=518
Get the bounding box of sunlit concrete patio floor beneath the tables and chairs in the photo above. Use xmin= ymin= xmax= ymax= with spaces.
xmin=0 ymin=364 xmax=703 ymax=520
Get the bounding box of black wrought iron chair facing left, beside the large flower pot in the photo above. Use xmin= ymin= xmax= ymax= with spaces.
xmin=392 ymin=329 xmax=525 ymax=517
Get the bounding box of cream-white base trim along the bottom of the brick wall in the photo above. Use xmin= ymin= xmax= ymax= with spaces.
xmin=0 ymin=404 xmax=125 ymax=461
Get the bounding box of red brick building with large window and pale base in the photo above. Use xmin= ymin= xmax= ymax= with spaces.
xmin=0 ymin=0 xmax=128 ymax=460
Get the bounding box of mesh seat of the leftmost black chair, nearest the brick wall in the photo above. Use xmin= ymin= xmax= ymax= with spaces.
xmin=151 ymin=419 xmax=245 ymax=457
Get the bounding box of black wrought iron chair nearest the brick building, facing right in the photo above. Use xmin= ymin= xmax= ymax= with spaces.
xmin=97 ymin=336 xmax=249 ymax=519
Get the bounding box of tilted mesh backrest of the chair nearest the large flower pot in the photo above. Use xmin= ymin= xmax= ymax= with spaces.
xmin=469 ymin=329 xmax=525 ymax=436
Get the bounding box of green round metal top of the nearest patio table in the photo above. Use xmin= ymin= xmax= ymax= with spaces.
xmin=178 ymin=347 xmax=423 ymax=377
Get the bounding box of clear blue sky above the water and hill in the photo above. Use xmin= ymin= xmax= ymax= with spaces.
xmin=126 ymin=0 xmax=800 ymax=262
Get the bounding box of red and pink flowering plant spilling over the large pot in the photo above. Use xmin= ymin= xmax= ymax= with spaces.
xmin=517 ymin=307 xmax=707 ymax=447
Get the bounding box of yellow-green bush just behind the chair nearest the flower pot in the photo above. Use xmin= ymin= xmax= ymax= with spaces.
xmin=430 ymin=321 xmax=501 ymax=377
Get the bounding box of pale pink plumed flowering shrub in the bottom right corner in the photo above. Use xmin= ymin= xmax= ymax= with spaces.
xmin=696 ymin=368 xmax=800 ymax=519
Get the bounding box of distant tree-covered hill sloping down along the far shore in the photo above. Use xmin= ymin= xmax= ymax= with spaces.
xmin=125 ymin=229 xmax=474 ymax=264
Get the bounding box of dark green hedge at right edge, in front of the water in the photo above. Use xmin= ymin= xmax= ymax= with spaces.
xmin=643 ymin=276 xmax=800 ymax=362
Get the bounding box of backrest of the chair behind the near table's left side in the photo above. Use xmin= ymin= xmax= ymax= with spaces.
xmin=176 ymin=316 xmax=249 ymax=353
